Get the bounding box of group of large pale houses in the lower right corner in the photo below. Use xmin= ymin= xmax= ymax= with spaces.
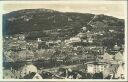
xmin=87 ymin=52 xmax=125 ymax=79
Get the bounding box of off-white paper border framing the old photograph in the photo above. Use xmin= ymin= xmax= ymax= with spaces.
xmin=0 ymin=0 xmax=128 ymax=81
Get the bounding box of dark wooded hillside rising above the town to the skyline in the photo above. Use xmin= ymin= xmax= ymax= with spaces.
xmin=3 ymin=9 xmax=124 ymax=46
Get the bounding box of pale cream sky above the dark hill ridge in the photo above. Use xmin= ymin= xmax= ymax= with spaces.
xmin=3 ymin=1 xmax=126 ymax=18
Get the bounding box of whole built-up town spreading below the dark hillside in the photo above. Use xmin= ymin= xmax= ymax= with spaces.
xmin=3 ymin=27 xmax=125 ymax=79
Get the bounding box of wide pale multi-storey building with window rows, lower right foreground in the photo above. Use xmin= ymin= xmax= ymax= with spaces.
xmin=86 ymin=62 xmax=105 ymax=74
